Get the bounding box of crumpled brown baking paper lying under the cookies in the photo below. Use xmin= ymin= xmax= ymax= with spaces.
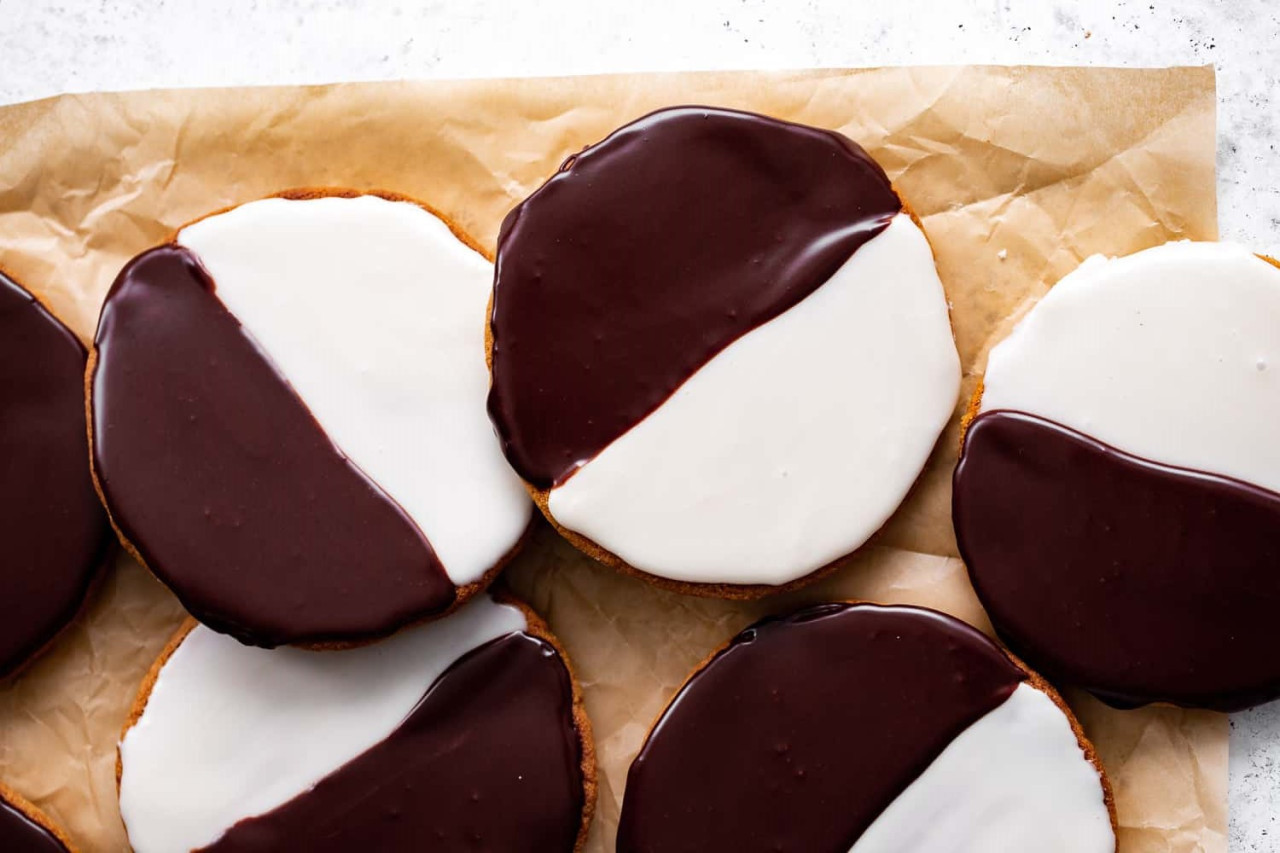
xmin=0 ymin=68 xmax=1228 ymax=853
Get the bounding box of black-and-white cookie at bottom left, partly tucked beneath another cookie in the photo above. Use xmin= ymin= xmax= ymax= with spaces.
xmin=118 ymin=593 xmax=595 ymax=853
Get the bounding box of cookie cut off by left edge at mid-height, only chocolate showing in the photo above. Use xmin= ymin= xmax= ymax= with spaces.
xmin=0 ymin=272 xmax=111 ymax=676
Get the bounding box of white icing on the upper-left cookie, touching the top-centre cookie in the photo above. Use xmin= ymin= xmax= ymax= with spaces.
xmin=178 ymin=196 xmax=531 ymax=585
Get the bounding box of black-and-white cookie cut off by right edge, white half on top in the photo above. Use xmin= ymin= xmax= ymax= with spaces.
xmin=952 ymin=242 xmax=1280 ymax=711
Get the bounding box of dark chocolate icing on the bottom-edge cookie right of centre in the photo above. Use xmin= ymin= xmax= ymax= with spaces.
xmin=617 ymin=605 xmax=1025 ymax=853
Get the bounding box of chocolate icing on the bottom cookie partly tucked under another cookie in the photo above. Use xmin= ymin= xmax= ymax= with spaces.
xmin=204 ymin=634 xmax=584 ymax=853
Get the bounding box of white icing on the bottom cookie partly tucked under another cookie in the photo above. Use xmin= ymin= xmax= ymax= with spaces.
xmin=120 ymin=594 xmax=526 ymax=853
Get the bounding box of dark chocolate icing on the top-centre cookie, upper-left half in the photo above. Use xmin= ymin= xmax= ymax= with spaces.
xmin=489 ymin=106 xmax=902 ymax=488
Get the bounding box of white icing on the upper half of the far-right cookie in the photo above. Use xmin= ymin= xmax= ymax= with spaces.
xmin=982 ymin=242 xmax=1280 ymax=492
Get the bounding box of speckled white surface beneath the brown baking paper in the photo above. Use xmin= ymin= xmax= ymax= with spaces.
xmin=0 ymin=0 xmax=1280 ymax=853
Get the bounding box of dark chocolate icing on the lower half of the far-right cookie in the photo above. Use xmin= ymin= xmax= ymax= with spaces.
xmin=952 ymin=411 xmax=1280 ymax=711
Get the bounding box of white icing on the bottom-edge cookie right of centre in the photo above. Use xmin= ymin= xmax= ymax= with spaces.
xmin=850 ymin=684 xmax=1116 ymax=853
